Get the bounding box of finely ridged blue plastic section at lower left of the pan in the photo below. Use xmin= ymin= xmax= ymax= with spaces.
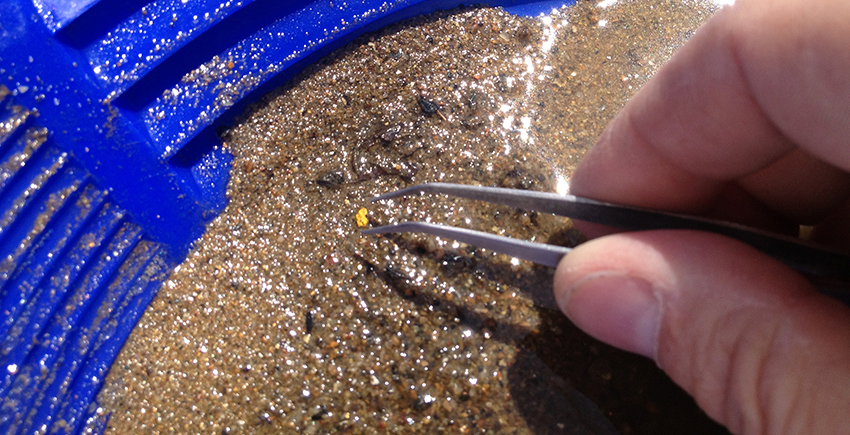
xmin=0 ymin=89 xmax=175 ymax=433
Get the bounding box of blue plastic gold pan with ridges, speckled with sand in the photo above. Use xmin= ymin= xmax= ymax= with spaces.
xmin=0 ymin=0 xmax=571 ymax=433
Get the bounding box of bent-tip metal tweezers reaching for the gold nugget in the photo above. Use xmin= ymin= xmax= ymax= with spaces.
xmin=362 ymin=183 xmax=850 ymax=282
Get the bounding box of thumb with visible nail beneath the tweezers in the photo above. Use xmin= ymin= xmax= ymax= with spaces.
xmin=554 ymin=231 xmax=850 ymax=434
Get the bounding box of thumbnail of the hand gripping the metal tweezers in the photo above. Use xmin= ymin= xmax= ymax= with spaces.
xmin=558 ymin=273 xmax=661 ymax=358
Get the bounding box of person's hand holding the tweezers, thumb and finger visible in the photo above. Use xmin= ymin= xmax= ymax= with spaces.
xmin=555 ymin=0 xmax=850 ymax=434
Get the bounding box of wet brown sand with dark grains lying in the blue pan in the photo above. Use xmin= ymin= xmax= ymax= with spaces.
xmin=94 ymin=0 xmax=724 ymax=434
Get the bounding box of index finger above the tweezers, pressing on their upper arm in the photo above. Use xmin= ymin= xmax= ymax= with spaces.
xmin=571 ymin=0 xmax=850 ymax=218
